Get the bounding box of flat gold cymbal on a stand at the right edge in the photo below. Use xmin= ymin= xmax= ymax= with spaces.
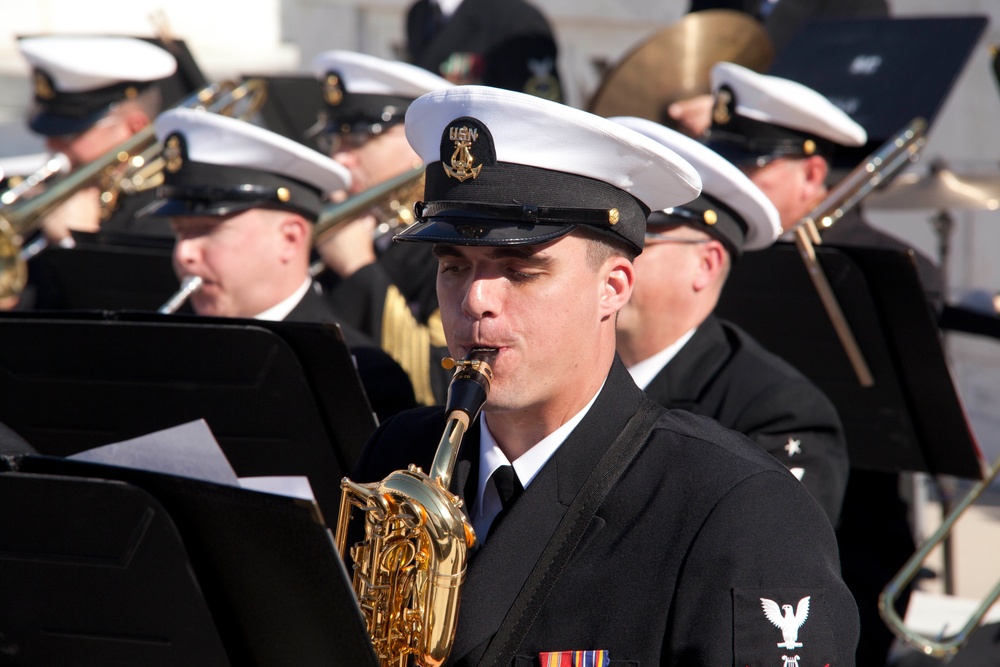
xmin=864 ymin=168 xmax=1000 ymax=211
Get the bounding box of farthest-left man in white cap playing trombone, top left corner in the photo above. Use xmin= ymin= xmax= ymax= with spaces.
xmin=18 ymin=35 xmax=177 ymax=242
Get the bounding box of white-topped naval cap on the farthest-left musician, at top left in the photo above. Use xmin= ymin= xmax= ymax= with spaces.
xmin=18 ymin=35 xmax=177 ymax=135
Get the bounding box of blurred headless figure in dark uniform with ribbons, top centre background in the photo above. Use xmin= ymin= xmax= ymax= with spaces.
xmin=406 ymin=0 xmax=563 ymax=102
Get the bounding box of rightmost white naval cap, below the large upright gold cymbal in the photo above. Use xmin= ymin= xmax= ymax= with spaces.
xmin=708 ymin=63 xmax=868 ymax=166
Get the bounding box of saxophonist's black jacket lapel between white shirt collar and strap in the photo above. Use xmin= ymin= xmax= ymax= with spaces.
xmin=449 ymin=357 xmax=642 ymax=662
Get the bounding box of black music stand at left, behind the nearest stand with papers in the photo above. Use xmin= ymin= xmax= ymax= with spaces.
xmin=0 ymin=313 xmax=375 ymax=517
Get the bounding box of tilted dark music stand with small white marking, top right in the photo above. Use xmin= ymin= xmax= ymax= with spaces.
xmin=768 ymin=16 xmax=987 ymax=169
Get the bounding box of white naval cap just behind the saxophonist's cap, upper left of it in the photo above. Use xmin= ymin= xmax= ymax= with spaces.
xmin=313 ymin=51 xmax=454 ymax=134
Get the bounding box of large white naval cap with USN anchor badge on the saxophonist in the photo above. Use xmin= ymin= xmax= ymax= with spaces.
xmin=396 ymin=86 xmax=701 ymax=252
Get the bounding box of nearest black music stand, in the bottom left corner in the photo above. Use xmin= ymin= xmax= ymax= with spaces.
xmin=0 ymin=456 xmax=378 ymax=667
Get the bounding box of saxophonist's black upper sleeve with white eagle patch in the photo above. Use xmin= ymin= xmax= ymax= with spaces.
xmin=665 ymin=471 xmax=858 ymax=665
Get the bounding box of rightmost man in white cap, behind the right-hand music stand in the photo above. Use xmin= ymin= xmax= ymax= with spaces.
xmin=708 ymin=63 xmax=942 ymax=664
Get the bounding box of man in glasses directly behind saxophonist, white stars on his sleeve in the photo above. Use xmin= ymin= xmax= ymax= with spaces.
xmin=611 ymin=117 xmax=849 ymax=526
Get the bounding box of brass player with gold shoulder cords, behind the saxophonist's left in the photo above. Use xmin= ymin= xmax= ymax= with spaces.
xmin=313 ymin=51 xmax=452 ymax=405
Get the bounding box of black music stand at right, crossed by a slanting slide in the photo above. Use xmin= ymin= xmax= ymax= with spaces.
xmin=716 ymin=243 xmax=983 ymax=479
